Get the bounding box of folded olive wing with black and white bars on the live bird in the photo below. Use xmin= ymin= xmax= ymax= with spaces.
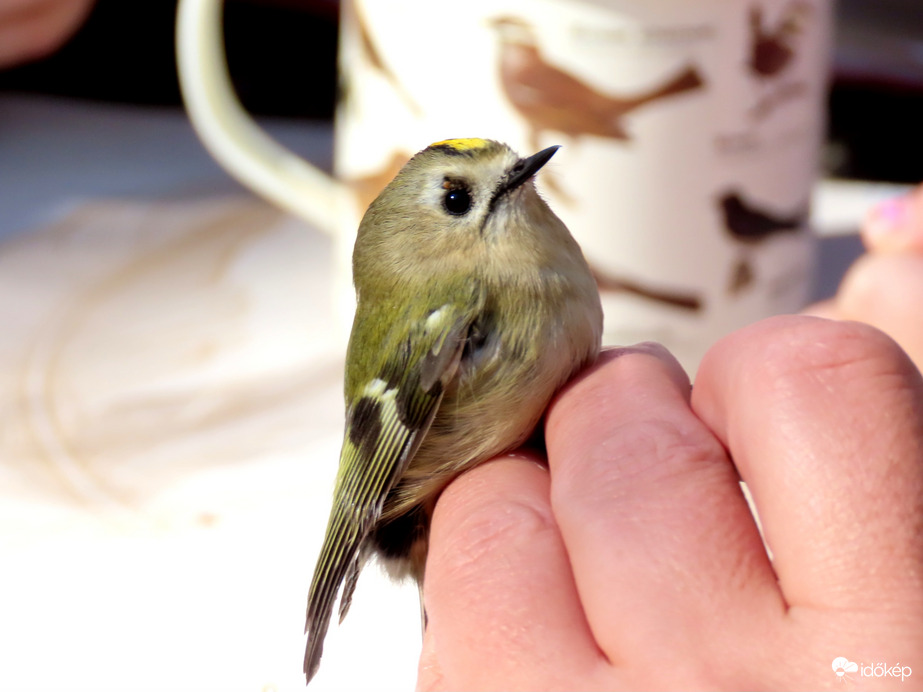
xmin=304 ymin=303 xmax=474 ymax=681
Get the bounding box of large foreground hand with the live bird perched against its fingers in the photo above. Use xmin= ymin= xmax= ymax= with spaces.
xmin=418 ymin=317 xmax=923 ymax=690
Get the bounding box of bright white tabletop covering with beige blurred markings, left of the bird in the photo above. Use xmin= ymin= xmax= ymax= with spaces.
xmin=0 ymin=196 xmax=420 ymax=692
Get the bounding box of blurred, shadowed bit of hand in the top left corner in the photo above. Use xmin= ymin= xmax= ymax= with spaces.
xmin=0 ymin=0 xmax=94 ymax=68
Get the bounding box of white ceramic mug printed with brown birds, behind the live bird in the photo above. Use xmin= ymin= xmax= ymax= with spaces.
xmin=178 ymin=0 xmax=833 ymax=370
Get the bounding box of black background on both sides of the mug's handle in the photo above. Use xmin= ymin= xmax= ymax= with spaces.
xmin=0 ymin=0 xmax=339 ymax=119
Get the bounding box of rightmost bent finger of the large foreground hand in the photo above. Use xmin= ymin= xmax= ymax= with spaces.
xmin=692 ymin=317 xmax=923 ymax=617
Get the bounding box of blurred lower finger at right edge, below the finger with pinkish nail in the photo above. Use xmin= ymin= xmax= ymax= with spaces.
xmin=836 ymin=253 xmax=923 ymax=367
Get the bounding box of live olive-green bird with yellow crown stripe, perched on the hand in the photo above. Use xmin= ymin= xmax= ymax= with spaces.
xmin=304 ymin=139 xmax=602 ymax=682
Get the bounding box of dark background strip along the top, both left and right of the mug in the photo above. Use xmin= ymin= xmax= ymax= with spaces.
xmin=0 ymin=0 xmax=923 ymax=183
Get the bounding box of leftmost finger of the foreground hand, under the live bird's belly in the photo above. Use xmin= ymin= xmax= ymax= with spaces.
xmin=419 ymin=457 xmax=607 ymax=689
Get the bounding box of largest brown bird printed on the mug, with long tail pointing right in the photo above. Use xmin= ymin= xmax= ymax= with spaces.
xmin=491 ymin=16 xmax=704 ymax=147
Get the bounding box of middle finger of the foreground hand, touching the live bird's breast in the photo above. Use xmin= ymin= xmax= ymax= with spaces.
xmin=546 ymin=345 xmax=781 ymax=672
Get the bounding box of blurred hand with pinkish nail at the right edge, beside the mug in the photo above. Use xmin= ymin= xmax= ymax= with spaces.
xmin=808 ymin=185 xmax=923 ymax=368
